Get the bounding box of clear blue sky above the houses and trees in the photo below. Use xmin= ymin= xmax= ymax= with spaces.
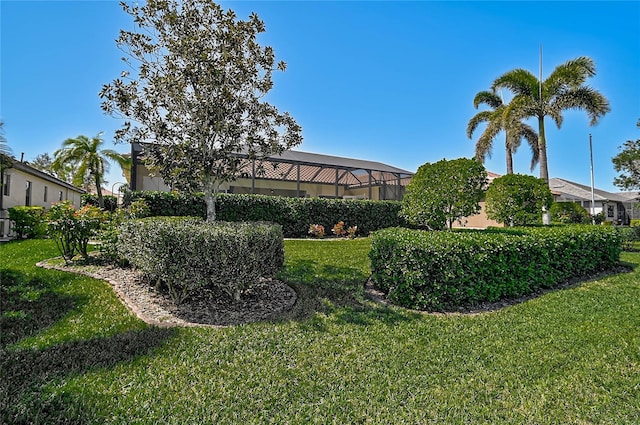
xmin=0 ymin=0 xmax=640 ymax=191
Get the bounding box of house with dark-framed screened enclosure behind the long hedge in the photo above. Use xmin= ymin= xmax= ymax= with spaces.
xmin=127 ymin=144 xmax=414 ymax=201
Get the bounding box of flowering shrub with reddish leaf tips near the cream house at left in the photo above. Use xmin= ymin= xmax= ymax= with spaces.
xmin=48 ymin=201 xmax=104 ymax=261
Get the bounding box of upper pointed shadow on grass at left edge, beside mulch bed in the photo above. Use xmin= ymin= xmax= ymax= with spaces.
xmin=0 ymin=269 xmax=84 ymax=347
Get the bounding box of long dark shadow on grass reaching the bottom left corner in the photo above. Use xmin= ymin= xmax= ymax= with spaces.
xmin=0 ymin=328 xmax=176 ymax=424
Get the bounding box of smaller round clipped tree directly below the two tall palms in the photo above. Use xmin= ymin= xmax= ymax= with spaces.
xmin=486 ymin=174 xmax=553 ymax=226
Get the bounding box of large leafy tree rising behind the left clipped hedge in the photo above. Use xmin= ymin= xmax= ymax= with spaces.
xmin=100 ymin=0 xmax=302 ymax=221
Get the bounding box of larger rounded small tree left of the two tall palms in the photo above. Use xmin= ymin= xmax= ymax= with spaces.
xmin=400 ymin=158 xmax=487 ymax=230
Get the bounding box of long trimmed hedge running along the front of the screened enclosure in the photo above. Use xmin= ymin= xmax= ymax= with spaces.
xmin=125 ymin=191 xmax=404 ymax=238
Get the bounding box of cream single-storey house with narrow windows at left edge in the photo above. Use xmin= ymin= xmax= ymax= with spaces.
xmin=0 ymin=159 xmax=85 ymax=238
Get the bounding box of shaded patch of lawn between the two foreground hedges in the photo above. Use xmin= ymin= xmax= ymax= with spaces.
xmin=278 ymin=260 xmax=420 ymax=331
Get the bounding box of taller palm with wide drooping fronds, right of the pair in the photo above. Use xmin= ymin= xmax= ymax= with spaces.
xmin=491 ymin=56 xmax=611 ymax=182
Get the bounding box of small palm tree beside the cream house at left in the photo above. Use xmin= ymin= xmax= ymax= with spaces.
xmin=53 ymin=132 xmax=127 ymax=208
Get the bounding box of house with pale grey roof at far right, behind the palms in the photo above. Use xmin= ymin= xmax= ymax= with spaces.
xmin=549 ymin=178 xmax=640 ymax=225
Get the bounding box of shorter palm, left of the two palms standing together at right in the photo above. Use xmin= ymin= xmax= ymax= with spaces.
xmin=467 ymin=91 xmax=538 ymax=174
